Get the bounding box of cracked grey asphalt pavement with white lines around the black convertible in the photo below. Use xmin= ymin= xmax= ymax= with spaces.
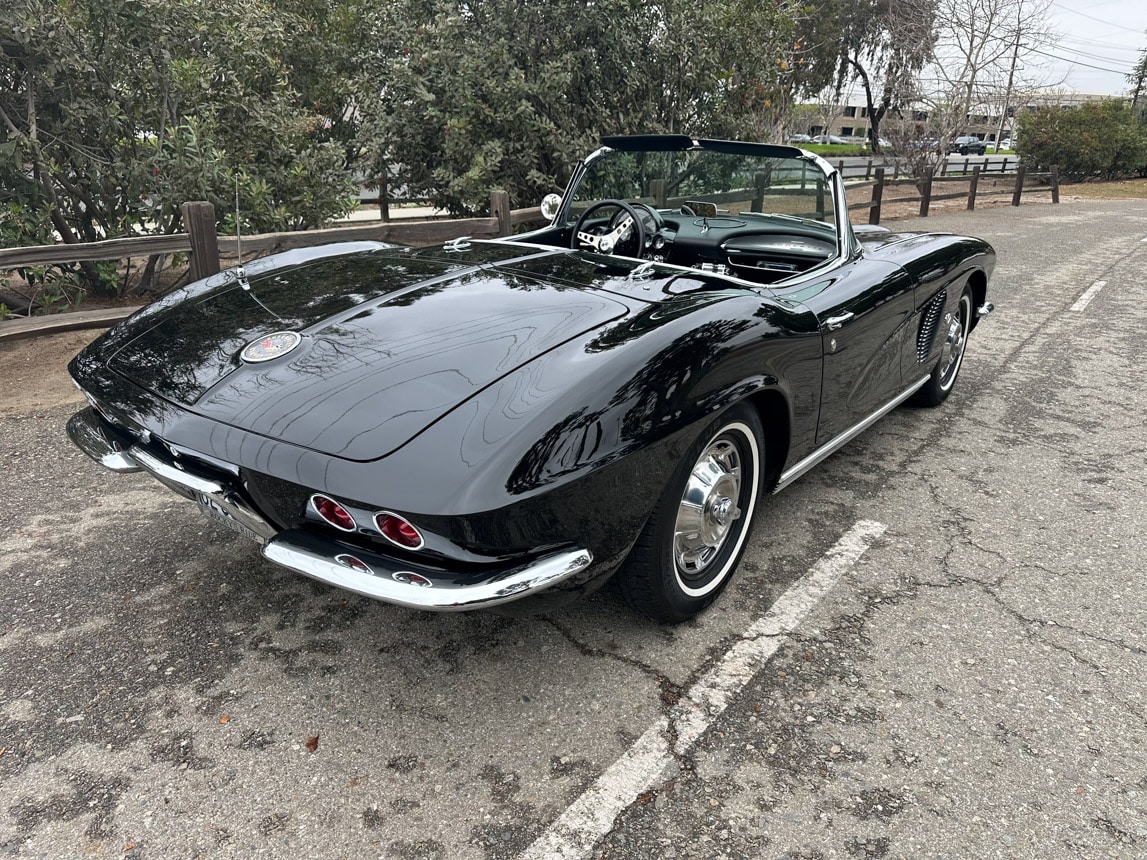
xmin=0 ymin=201 xmax=1147 ymax=860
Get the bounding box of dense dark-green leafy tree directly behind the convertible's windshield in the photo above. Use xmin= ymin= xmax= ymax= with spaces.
xmin=356 ymin=0 xmax=787 ymax=213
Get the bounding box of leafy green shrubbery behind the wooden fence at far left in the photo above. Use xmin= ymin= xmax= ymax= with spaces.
xmin=0 ymin=0 xmax=352 ymax=292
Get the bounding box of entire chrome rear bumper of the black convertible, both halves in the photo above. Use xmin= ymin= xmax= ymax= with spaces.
xmin=68 ymin=407 xmax=593 ymax=612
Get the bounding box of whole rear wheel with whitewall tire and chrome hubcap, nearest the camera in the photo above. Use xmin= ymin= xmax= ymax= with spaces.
xmin=616 ymin=405 xmax=765 ymax=623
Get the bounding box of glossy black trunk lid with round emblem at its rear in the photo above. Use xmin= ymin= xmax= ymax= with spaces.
xmin=109 ymin=245 xmax=627 ymax=461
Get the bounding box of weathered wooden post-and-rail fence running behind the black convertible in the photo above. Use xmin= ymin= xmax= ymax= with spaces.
xmin=0 ymin=165 xmax=1060 ymax=302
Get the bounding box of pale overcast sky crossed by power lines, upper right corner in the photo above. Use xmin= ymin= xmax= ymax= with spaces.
xmin=1032 ymin=0 xmax=1147 ymax=95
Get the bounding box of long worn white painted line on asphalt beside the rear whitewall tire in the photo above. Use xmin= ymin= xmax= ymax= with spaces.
xmin=521 ymin=519 xmax=885 ymax=860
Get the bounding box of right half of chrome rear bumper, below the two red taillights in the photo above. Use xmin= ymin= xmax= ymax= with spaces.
xmin=263 ymin=532 xmax=593 ymax=612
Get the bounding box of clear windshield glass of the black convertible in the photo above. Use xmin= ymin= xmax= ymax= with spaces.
xmin=568 ymin=148 xmax=835 ymax=228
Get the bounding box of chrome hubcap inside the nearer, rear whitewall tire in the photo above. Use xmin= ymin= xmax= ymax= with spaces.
xmin=673 ymin=438 xmax=741 ymax=577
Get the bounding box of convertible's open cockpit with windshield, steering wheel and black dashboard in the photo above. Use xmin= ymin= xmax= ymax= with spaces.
xmin=532 ymin=135 xmax=846 ymax=283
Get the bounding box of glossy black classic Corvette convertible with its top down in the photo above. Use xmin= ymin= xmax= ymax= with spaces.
xmin=68 ymin=135 xmax=994 ymax=621
